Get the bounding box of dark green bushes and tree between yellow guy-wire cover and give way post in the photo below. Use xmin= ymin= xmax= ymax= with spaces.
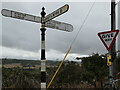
xmin=48 ymin=54 xmax=108 ymax=88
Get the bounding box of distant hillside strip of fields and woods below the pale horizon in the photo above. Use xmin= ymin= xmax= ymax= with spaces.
xmin=2 ymin=58 xmax=59 ymax=66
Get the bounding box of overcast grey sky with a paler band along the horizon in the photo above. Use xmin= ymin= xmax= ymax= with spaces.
xmin=0 ymin=0 xmax=120 ymax=60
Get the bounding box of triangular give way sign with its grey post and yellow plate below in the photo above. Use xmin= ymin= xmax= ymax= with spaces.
xmin=98 ymin=30 xmax=119 ymax=90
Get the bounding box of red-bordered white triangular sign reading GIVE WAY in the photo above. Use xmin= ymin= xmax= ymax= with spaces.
xmin=98 ymin=30 xmax=119 ymax=51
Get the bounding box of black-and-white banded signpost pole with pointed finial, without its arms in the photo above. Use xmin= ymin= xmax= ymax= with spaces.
xmin=40 ymin=7 xmax=46 ymax=90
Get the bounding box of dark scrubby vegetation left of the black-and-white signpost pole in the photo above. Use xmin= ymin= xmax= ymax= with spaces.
xmin=2 ymin=68 xmax=40 ymax=88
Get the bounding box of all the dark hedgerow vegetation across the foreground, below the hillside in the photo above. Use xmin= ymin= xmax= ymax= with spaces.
xmin=2 ymin=54 xmax=120 ymax=88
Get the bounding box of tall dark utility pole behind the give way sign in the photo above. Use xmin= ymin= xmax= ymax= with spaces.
xmin=109 ymin=0 xmax=116 ymax=90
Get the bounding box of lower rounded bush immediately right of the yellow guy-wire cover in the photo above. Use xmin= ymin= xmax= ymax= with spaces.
xmin=51 ymin=61 xmax=82 ymax=88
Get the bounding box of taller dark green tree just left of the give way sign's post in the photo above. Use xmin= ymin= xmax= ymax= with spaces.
xmin=81 ymin=54 xmax=108 ymax=87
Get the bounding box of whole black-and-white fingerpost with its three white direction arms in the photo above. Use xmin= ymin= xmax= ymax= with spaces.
xmin=1 ymin=4 xmax=73 ymax=90
